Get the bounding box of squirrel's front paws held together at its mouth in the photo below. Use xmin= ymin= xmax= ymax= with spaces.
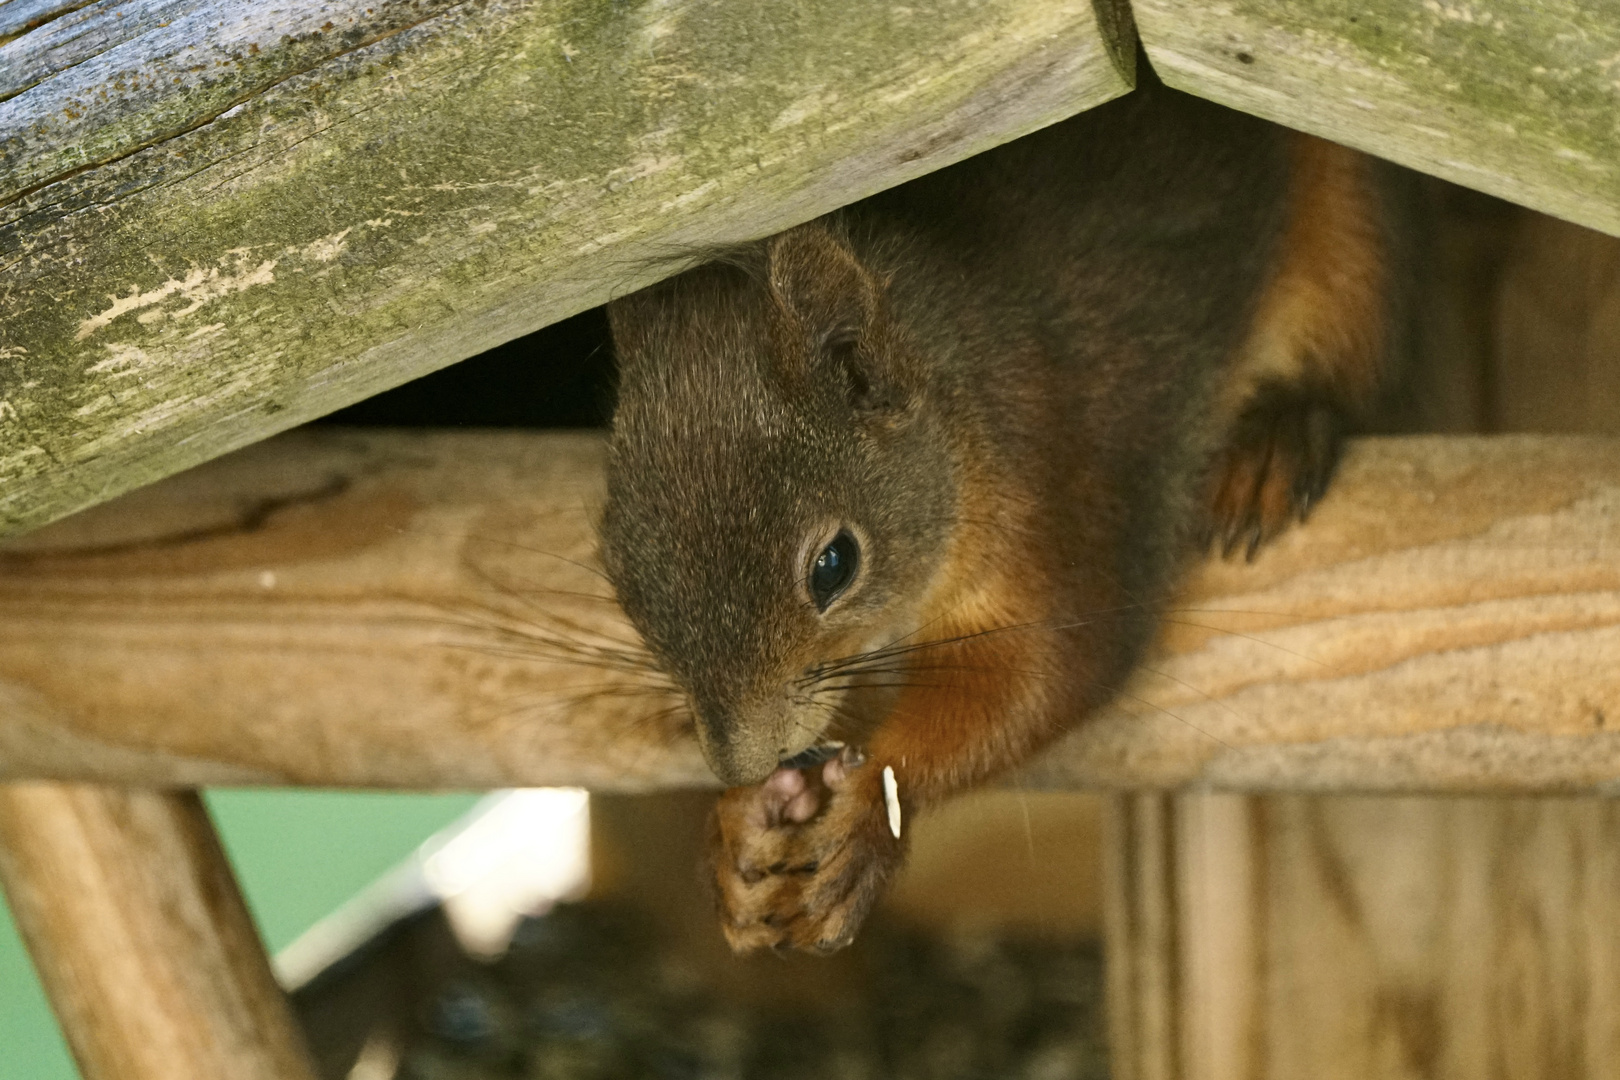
xmin=710 ymin=748 xmax=904 ymax=952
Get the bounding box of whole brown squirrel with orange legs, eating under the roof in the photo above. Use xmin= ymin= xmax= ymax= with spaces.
xmin=601 ymin=65 xmax=1390 ymax=952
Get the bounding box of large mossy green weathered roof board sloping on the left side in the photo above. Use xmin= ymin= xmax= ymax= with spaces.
xmin=0 ymin=0 xmax=1134 ymax=534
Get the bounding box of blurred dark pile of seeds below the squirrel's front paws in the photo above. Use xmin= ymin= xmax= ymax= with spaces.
xmin=301 ymin=904 xmax=1108 ymax=1080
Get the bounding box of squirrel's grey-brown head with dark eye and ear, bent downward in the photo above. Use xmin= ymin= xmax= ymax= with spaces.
xmin=601 ymin=222 xmax=956 ymax=785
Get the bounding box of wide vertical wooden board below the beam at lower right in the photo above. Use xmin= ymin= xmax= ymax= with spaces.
xmin=1106 ymin=793 xmax=1620 ymax=1080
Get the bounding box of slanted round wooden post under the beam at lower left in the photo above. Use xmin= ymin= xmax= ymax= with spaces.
xmin=0 ymin=784 xmax=316 ymax=1080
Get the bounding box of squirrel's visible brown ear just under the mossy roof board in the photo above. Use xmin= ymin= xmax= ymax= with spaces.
xmin=768 ymin=222 xmax=909 ymax=413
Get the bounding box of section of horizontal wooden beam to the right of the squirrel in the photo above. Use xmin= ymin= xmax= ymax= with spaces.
xmin=1030 ymin=436 xmax=1620 ymax=792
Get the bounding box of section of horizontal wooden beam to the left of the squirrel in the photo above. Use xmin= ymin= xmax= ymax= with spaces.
xmin=0 ymin=432 xmax=710 ymax=790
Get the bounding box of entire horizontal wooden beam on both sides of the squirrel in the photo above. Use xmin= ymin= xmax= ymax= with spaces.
xmin=0 ymin=432 xmax=1620 ymax=792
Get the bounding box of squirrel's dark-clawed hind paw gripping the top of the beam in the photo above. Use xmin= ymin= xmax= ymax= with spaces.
xmin=1204 ymin=385 xmax=1346 ymax=560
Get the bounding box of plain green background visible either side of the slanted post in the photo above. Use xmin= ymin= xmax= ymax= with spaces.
xmin=0 ymin=790 xmax=480 ymax=1080
